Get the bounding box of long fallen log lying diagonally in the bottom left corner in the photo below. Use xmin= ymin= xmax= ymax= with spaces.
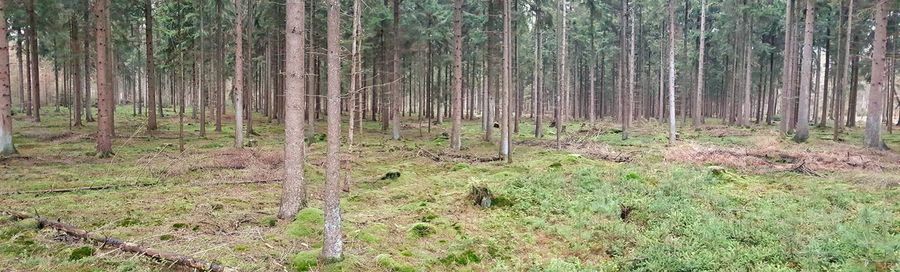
xmin=0 ymin=211 xmax=237 ymax=272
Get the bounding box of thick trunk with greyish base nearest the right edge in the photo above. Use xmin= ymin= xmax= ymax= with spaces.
xmin=865 ymin=0 xmax=893 ymax=150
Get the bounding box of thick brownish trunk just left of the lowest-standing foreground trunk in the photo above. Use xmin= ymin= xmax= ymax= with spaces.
xmin=278 ymin=0 xmax=306 ymax=220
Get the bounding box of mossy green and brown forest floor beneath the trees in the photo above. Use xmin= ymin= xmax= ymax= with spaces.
xmin=0 ymin=107 xmax=900 ymax=271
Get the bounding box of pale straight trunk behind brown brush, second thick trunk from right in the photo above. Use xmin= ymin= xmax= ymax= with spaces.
xmin=794 ymin=0 xmax=816 ymax=143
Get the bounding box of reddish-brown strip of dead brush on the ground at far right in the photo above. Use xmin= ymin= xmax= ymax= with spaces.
xmin=665 ymin=144 xmax=900 ymax=175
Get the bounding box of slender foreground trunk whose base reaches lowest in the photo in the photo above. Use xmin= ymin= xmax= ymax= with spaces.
xmin=322 ymin=0 xmax=342 ymax=262
